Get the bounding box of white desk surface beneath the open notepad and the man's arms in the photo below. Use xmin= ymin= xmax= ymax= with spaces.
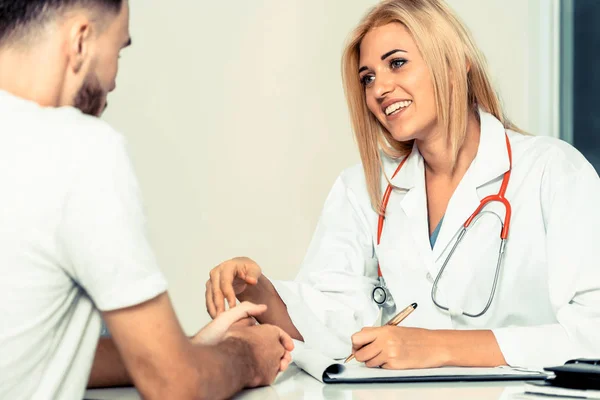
xmin=85 ymin=365 xmax=538 ymax=400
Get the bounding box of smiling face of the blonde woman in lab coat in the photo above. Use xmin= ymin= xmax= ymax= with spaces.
xmin=359 ymin=22 xmax=437 ymax=142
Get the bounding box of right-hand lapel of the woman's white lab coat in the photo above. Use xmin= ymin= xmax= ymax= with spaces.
xmin=433 ymin=109 xmax=510 ymax=262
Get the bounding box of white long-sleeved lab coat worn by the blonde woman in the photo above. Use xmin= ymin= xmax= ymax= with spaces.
xmin=274 ymin=112 xmax=600 ymax=367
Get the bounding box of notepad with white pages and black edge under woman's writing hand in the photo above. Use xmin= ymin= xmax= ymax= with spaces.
xmin=292 ymin=345 xmax=548 ymax=383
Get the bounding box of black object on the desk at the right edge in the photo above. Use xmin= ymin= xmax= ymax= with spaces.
xmin=544 ymin=358 xmax=600 ymax=390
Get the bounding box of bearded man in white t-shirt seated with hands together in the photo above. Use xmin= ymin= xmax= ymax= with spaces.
xmin=0 ymin=0 xmax=293 ymax=399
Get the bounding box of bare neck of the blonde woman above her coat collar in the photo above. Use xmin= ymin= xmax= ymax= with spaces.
xmin=417 ymin=108 xmax=481 ymax=180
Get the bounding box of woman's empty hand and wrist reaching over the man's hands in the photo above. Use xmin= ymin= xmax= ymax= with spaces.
xmin=206 ymin=257 xmax=304 ymax=341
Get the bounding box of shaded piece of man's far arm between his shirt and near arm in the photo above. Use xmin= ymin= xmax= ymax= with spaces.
xmin=88 ymin=338 xmax=133 ymax=388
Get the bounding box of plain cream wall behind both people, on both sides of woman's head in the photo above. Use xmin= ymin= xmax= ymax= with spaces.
xmin=105 ymin=0 xmax=556 ymax=333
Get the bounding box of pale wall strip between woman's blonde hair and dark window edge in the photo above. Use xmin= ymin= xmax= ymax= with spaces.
xmin=447 ymin=0 xmax=558 ymax=137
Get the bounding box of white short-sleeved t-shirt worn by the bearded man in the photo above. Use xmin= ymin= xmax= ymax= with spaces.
xmin=0 ymin=91 xmax=167 ymax=399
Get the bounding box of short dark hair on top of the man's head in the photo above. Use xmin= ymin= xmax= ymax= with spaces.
xmin=0 ymin=0 xmax=125 ymax=45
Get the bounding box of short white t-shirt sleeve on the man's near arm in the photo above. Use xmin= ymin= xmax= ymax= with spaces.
xmin=58 ymin=132 xmax=167 ymax=311
